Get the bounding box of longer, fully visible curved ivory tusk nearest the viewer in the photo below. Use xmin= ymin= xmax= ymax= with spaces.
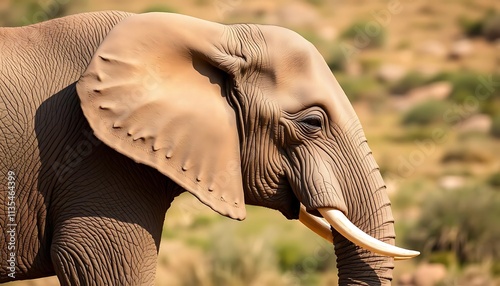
xmin=318 ymin=208 xmax=420 ymax=260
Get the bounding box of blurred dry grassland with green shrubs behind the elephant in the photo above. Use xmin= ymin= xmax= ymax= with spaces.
xmin=0 ymin=0 xmax=500 ymax=286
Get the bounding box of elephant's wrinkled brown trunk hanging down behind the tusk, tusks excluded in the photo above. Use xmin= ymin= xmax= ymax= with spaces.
xmin=332 ymin=131 xmax=395 ymax=285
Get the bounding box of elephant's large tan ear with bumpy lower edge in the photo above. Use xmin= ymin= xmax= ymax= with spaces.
xmin=76 ymin=14 xmax=246 ymax=220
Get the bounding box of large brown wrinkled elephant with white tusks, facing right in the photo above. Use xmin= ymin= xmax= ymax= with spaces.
xmin=0 ymin=12 xmax=418 ymax=285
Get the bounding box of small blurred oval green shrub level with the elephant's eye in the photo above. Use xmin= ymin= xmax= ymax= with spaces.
xmin=402 ymin=100 xmax=449 ymax=126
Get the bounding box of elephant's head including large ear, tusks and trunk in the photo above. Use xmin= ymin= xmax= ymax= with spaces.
xmin=77 ymin=13 xmax=418 ymax=283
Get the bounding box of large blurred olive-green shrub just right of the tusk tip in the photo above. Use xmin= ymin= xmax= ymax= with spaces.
xmin=407 ymin=187 xmax=500 ymax=265
